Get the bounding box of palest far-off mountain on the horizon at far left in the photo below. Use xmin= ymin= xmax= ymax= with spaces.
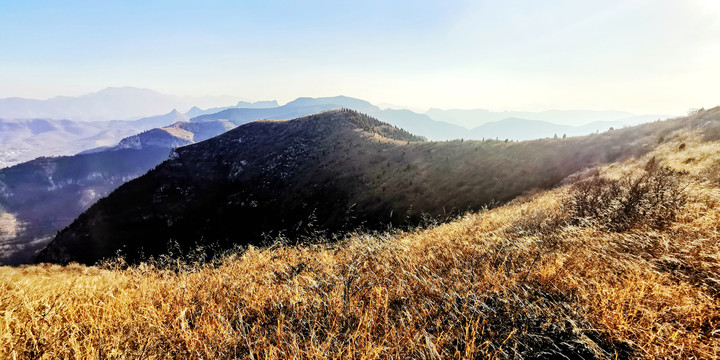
xmin=0 ymin=87 xmax=233 ymax=121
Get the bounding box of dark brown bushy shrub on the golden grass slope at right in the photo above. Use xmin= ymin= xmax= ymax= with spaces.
xmin=565 ymin=158 xmax=686 ymax=232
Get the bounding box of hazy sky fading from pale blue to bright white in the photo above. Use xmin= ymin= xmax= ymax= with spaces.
xmin=0 ymin=0 xmax=720 ymax=114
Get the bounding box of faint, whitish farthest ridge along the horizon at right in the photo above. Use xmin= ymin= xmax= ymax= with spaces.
xmin=425 ymin=108 xmax=671 ymax=129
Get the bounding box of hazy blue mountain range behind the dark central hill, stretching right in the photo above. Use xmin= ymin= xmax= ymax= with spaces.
xmin=192 ymin=96 xmax=667 ymax=141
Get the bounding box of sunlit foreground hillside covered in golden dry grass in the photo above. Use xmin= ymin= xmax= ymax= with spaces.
xmin=0 ymin=109 xmax=720 ymax=359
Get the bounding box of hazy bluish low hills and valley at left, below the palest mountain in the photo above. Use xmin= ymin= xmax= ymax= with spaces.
xmin=0 ymin=110 xmax=188 ymax=168
